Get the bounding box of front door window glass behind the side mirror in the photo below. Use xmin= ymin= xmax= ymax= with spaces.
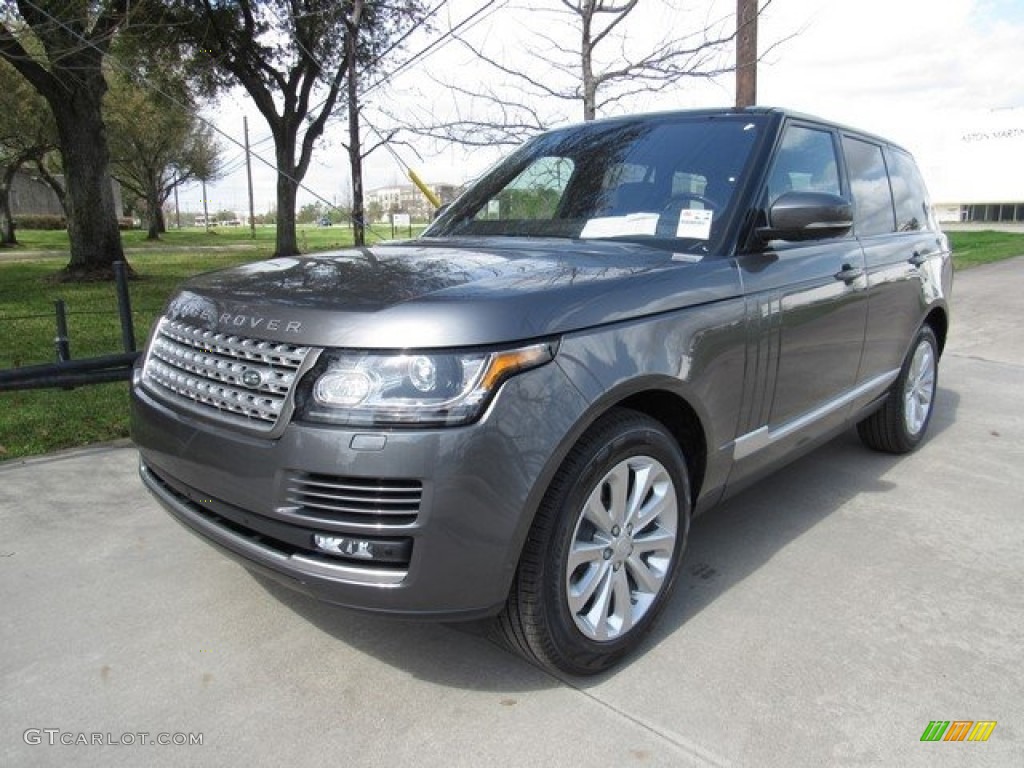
xmin=768 ymin=125 xmax=840 ymax=205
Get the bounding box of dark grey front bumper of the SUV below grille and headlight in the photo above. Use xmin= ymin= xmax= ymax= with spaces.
xmin=132 ymin=365 xmax=584 ymax=620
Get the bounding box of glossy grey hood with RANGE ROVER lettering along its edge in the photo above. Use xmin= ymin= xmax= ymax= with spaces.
xmin=161 ymin=239 xmax=738 ymax=349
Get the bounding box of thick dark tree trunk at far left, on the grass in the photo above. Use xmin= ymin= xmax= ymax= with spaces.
xmin=46 ymin=85 xmax=125 ymax=279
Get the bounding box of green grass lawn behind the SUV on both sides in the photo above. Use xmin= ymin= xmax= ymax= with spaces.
xmin=0 ymin=227 xmax=1024 ymax=461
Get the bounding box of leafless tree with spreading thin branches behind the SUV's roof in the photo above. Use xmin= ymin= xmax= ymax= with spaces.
xmin=404 ymin=0 xmax=772 ymax=145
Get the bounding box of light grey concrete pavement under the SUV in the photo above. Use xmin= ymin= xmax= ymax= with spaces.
xmin=0 ymin=258 xmax=1024 ymax=768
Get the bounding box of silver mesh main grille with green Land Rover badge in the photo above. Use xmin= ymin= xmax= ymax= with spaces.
xmin=143 ymin=318 xmax=309 ymax=430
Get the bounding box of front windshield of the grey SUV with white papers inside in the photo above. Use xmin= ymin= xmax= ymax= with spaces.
xmin=424 ymin=115 xmax=763 ymax=250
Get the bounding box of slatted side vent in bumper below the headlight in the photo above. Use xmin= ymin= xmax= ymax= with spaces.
xmin=287 ymin=472 xmax=423 ymax=526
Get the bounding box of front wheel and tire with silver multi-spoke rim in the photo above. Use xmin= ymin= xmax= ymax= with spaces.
xmin=497 ymin=409 xmax=690 ymax=675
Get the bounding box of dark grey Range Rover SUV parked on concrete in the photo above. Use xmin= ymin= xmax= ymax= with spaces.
xmin=132 ymin=109 xmax=952 ymax=674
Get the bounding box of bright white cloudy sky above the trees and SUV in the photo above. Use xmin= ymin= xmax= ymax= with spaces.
xmin=180 ymin=0 xmax=1024 ymax=218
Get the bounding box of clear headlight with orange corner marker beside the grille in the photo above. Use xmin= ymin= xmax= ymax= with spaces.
xmin=297 ymin=342 xmax=556 ymax=426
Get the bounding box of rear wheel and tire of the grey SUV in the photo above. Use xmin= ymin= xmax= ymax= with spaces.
xmin=857 ymin=326 xmax=939 ymax=454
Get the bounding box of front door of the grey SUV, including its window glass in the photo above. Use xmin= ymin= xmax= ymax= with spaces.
xmin=733 ymin=123 xmax=867 ymax=479
